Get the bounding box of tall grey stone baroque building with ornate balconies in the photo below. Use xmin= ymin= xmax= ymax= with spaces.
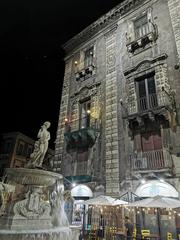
xmin=54 ymin=0 xmax=180 ymax=196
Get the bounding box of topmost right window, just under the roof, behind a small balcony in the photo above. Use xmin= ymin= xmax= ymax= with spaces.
xmin=134 ymin=15 xmax=149 ymax=38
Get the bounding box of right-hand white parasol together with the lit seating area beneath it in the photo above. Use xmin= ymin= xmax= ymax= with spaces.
xmin=129 ymin=196 xmax=180 ymax=239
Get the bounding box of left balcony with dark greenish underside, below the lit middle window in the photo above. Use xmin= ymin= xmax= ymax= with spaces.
xmin=64 ymin=117 xmax=99 ymax=152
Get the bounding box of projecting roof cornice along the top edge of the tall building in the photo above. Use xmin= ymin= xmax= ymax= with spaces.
xmin=62 ymin=0 xmax=147 ymax=53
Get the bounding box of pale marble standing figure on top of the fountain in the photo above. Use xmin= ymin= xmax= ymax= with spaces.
xmin=27 ymin=122 xmax=51 ymax=168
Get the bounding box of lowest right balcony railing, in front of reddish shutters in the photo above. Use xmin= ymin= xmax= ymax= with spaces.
xmin=129 ymin=149 xmax=173 ymax=172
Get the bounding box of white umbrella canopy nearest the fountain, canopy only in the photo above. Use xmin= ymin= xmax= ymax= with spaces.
xmin=84 ymin=195 xmax=128 ymax=206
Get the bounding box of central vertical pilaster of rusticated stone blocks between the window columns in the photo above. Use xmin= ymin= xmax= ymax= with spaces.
xmin=105 ymin=28 xmax=120 ymax=196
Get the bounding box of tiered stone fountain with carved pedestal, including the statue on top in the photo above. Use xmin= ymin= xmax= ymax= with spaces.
xmin=0 ymin=122 xmax=79 ymax=240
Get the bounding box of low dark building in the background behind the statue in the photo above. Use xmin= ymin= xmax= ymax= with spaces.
xmin=0 ymin=132 xmax=54 ymax=176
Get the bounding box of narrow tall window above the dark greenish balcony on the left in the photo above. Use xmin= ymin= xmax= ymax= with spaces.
xmin=79 ymin=100 xmax=91 ymax=128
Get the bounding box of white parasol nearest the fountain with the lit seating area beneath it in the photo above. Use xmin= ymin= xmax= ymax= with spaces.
xmin=84 ymin=195 xmax=128 ymax=240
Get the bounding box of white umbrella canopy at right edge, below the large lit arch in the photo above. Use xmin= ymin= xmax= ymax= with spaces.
xmin=129 ymin=196 xmax=180 ymax=208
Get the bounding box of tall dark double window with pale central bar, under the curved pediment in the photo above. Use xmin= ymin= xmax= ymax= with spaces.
xmin=136 ymin=75 xmax=158 ymax=112
